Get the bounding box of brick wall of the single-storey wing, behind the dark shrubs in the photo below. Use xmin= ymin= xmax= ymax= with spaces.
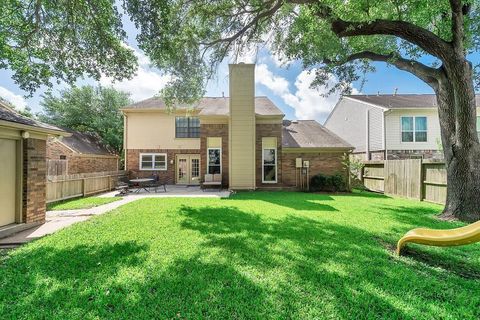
xmin=282 ymin=152 xmax=347 ymax=186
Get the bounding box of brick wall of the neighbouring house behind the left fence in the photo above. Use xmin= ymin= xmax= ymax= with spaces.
xmin=47 ymin=139 xmax=118 ymax=174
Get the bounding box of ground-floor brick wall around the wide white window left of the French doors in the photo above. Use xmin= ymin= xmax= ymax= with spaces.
xmin=126 ymin=149 xmax=202 ymax=184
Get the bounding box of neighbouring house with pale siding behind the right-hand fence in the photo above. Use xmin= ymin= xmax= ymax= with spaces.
xmin=324 ymin=94 xmax=480 ymax=160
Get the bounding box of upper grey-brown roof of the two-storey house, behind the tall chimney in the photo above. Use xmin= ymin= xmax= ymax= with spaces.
xmin=122 ymin=96 xmax=284 ymax=116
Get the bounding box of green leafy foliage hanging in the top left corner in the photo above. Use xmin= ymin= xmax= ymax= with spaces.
xmin=0 ymin=0 xmax=137 ymax=92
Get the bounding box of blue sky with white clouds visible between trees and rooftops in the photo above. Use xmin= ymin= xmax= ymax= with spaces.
xmin=0 ymin=9 xmax=480 ymax=123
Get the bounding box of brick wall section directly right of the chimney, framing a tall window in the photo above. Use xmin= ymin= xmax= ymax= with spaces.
xmin=255 ymin=124 xmax=283 ymax=188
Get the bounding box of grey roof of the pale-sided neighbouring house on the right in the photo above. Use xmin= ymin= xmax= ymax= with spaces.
xmin=345 ymin=94 xmax=480 ymax=109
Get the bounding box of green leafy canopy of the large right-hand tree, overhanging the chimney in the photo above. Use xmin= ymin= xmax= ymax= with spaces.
xmin=124 ymin=0 xmax=480 ymax=102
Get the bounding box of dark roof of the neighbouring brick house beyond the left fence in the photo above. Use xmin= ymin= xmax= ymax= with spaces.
xmin=55 ymin=129 xmax=114 ymax=155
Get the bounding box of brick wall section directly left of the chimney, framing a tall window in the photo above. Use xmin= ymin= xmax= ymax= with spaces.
xmin=200 ymin=124 xmax=229 ymax=187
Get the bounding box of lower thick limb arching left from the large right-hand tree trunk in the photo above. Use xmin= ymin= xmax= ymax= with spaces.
xmin=336 ymin=51 xmax=440 ymax=89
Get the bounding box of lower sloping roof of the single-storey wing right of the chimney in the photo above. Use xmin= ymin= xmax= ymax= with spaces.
xmin=282 ymin=120 xmax=353 ymax=149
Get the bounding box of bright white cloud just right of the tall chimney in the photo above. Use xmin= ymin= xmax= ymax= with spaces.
xmin=255 ymin=64 xmax=358 ymax=123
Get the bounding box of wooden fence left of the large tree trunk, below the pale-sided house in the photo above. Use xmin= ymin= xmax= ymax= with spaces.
xmin=362 ymin=159 xmax=447 ymax=204
